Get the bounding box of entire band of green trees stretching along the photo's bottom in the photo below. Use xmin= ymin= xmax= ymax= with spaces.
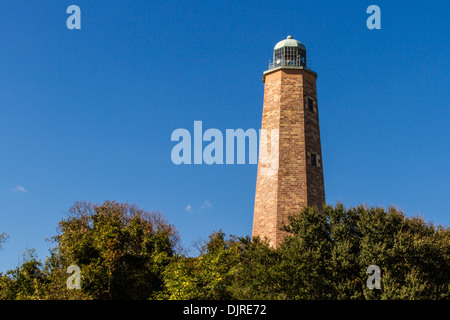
xmin=0 ymin=201 xmax=450 ymax=300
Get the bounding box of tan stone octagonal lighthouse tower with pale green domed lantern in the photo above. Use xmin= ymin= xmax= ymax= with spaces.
xmin=253 ymin=36 xmax=325 ymax=247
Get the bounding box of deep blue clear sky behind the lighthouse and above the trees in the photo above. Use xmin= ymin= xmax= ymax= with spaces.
xmin=0 ymin=0 xmax=450 ymax=272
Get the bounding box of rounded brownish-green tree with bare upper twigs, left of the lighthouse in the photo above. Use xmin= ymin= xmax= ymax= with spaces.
xmin=48 ymin=201 xmax=179 ymax=299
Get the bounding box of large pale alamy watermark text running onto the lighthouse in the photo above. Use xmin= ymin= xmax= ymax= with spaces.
xmin=171 ymin=121 xmax=279 ymax=175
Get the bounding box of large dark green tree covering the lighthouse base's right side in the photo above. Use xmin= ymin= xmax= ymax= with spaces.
xmin=280 ymin=204 xmax=450 ymax=299
